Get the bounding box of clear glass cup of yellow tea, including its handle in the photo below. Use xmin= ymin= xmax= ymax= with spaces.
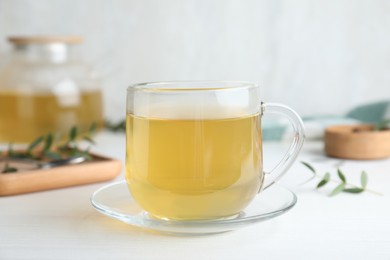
xmin=126 ymin=81 xmax=304 ymax=220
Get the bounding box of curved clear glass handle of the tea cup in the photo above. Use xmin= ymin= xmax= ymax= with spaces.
xmin=261 ymin=103 xmax=305 ymax=190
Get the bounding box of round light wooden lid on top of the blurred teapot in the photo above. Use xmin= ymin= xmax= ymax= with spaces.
xmin=8 ymin=35 xmax=83 ymax=45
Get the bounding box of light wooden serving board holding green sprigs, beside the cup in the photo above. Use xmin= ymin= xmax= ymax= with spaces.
xmin=0 ymin=154 xmax=122 ymax=196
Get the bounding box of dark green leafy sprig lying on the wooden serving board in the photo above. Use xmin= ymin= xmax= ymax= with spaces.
xmin=1 ymin=123 xmax=96 ymax=173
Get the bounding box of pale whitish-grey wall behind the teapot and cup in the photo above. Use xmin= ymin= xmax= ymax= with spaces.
xmin=0 ymin=0 xmax=390 ymax=120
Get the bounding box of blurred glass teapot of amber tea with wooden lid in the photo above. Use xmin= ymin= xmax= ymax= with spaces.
xmin=0 ymin=36 xmax=103 ymax=143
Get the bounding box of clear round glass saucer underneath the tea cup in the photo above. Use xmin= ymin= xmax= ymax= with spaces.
xmin=91 ymin=181 xmax=297 ymax=235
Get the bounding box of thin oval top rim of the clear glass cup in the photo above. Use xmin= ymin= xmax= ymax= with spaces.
xmin=127 ymin=80 xmax=259 ymax=92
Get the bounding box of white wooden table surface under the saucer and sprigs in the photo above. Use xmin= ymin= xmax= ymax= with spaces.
xmin=0 ymin=133 xmax=390 ymax=260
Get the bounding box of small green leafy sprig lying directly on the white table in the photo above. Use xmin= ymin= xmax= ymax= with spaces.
xmin=301 ymin=162 xmax=383 ymax=196
